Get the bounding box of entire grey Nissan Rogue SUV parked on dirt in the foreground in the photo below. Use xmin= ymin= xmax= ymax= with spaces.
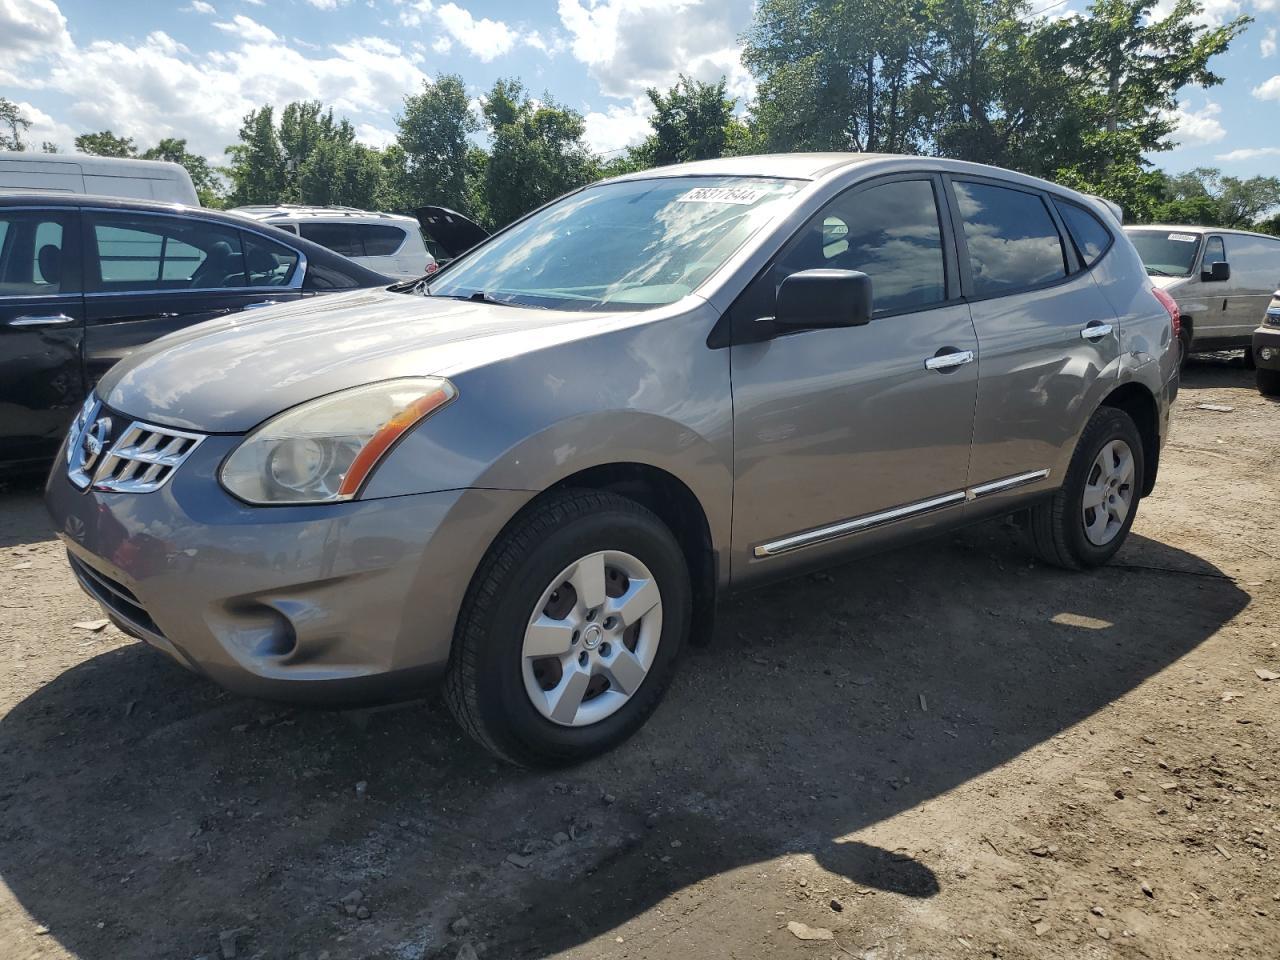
xmin=47 ymin=154 xmax=1178 ymax=764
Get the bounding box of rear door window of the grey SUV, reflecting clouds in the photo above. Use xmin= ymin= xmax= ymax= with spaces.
xmin=954 ymin=180 xmax=1066 ymax=297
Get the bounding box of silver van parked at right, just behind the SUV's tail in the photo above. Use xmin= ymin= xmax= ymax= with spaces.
xmin=1125 ymin=225 xmax=1280 ymax=362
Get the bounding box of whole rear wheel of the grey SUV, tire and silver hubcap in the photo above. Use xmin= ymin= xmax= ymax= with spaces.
xmin=1030 ymin=407 xmax=1146 ymax=570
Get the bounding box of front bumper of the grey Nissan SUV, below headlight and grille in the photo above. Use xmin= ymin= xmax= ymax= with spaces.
xmin=45 ymin=435 xmax=532 ymax=703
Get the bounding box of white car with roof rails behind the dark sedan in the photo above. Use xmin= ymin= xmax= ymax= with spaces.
xmin=234 ymin=204 xmax=439 ymax=279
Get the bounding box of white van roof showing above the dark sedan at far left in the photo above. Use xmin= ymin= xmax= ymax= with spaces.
xmin=0 ymin=150 xmax=200 ymax=206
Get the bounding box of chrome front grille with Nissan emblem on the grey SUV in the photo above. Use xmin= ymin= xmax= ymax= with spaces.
xmin=67 ymin=397 xmax=205 ymax=493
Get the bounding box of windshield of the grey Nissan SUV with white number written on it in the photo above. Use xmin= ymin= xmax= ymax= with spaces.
xmin=429 ymin=177 xmax=804 ymax=310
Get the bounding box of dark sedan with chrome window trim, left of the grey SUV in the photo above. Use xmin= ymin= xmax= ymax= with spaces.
xmin=0 ymin=193 xmax=392 ymax=470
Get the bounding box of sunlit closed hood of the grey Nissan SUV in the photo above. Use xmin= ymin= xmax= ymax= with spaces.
xmin=97 ymin=289 xmax=616 ymax=433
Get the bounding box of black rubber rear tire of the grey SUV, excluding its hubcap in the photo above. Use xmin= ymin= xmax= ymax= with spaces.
xmin=1028 ymin=407 xmax=1146 ymax=570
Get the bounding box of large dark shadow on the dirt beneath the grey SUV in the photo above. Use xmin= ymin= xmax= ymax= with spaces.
xmin=0 ymin=512 xmax=1248 ymax=960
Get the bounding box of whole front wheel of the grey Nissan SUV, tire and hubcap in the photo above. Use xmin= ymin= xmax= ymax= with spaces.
xmin=445 ymin=490 xmax=692 ymax=767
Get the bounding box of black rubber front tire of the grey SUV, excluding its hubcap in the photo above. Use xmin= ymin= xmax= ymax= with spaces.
xmin=444 ymin=490 xmax=692 ymax=767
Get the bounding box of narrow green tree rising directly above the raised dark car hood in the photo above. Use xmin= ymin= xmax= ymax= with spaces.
xmin=396 ymin=73 xmax=480 ymax=215
